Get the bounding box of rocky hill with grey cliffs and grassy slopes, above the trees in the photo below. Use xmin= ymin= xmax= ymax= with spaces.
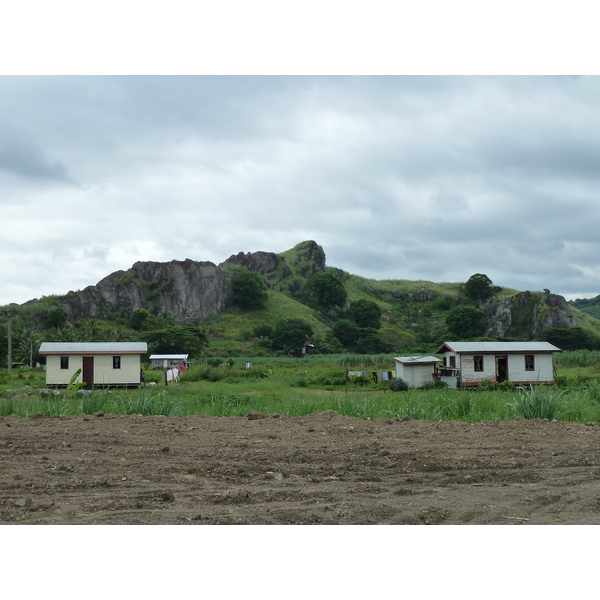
xmin=14 ymin=241 xmax=600 ymax=348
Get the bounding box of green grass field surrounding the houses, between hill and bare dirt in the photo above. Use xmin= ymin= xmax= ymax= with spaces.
xmin=0 ymin=351 xmax=600 ymax=423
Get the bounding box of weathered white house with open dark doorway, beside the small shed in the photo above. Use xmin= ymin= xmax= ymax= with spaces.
xmin=436 ymin=342 xmax=561 ymax=387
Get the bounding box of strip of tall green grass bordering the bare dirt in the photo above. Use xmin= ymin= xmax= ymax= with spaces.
xmin=0 ymin=382 xmax=600 ymax=422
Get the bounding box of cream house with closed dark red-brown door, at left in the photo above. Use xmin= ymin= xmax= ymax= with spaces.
xmin=40 ymin=342 xmax=148 ymax=387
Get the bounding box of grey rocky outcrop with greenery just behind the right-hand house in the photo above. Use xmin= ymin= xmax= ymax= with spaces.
xmin=482 ymin=292 xmax=577 ymax=339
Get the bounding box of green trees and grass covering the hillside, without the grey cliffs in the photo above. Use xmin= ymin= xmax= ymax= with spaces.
xmin=0 ymin=243 xmax=600 ymax=376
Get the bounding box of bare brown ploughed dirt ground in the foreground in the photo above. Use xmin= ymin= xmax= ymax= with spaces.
xmin=0 ymin=413 xmax=600 ymax=525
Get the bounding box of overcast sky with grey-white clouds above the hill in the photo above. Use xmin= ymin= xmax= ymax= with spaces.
xmin=0 ymin=76 xmax=600 ymax=304
